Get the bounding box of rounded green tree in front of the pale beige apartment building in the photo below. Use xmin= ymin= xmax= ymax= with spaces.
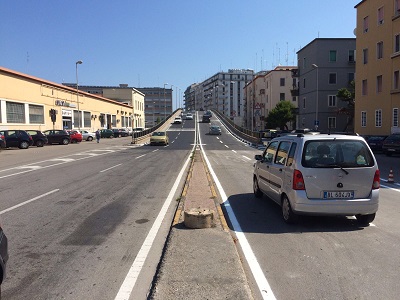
xmin=266 ymin=101 xmax=296 ymax=130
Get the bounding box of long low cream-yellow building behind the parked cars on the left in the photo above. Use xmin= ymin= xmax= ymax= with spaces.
xmin=0 ymin=67 xmax=144 ymax=131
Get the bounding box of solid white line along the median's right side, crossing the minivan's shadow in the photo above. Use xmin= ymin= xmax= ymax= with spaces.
xmin=199 ymin=137 xmax=276 ymax=300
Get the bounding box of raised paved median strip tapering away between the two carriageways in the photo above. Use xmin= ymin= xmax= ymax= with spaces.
xmin=149 ymin=149 xmax=253 ymax=300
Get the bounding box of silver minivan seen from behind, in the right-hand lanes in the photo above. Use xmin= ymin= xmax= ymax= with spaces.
xmin=253 ymin=134 xmax=380 ymax=226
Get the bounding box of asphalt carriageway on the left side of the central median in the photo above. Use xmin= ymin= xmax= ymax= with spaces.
xmin=0 ymin=122 xmax=194 ymax=299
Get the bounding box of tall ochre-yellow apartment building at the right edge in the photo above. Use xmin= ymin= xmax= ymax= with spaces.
xmin=355 ymin=0 xmax=400 ymax=135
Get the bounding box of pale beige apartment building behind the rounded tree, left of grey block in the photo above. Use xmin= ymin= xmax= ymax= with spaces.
xmin=244 ymin=66 xmax=297 ymax=131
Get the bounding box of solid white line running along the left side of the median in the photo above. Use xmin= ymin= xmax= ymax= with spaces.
xmin=115 ymin=147 xmax=194 ymax=300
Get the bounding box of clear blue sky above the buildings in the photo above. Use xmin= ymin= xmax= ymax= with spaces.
xmin=0 ymin=0 xmax=360 ymax=108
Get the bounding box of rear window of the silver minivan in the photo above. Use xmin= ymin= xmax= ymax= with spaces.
xmin=302 ymin=139 xmax=374 ymax=168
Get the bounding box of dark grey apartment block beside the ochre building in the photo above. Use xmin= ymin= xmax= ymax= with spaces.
xmin=296 ymin=38 xmax=356 ymax=131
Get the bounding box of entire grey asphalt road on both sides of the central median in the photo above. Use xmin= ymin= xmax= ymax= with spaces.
xmin=0 ymin=114 xmax=400 ymax=300
